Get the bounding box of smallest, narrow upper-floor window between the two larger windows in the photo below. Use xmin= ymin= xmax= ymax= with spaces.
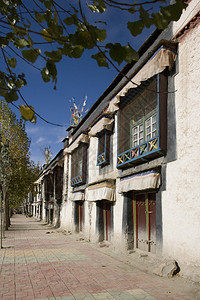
xmin=97 ymin=130 xmax=110 ymax=166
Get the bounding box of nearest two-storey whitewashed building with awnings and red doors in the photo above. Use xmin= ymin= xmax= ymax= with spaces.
xmin=36 ymin=0 xmax=200 ymax=280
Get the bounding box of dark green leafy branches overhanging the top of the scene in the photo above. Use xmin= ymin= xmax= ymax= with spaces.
xmin=0 ymin=0 xmax=186 ymax=122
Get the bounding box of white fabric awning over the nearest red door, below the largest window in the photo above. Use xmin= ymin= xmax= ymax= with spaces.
xmin=118 ymin=170 xmax=161 ymax=193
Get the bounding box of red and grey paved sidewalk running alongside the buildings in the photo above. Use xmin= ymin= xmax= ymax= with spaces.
xmin=0 ymin=215 xmax=200 ymax=300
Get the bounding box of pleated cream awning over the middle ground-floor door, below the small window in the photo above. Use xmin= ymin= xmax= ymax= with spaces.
xmin=86 ymin=181 xmax=115 ymax=201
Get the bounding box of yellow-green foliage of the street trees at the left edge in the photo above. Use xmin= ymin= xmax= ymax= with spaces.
xmin=0 ymin=100 xmax=39 ymax=211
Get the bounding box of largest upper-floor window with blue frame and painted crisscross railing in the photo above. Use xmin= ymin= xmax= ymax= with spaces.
xmin=117 ymin=73 xmax=167 ymax=168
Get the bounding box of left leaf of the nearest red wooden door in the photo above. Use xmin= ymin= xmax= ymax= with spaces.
xmin=135 ymin=194 xmax=147 ymax=250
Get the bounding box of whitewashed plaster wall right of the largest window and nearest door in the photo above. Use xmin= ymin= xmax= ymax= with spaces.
xmin=162 ymin=21 xmax=200 ymax=274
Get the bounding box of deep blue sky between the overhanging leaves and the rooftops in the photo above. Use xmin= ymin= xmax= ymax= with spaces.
xmin=7 ymin=1 xmax=159 ymax=164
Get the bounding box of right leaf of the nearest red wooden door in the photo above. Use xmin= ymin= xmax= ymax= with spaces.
xmin=148 ymin=193 xmax=156 ymax=253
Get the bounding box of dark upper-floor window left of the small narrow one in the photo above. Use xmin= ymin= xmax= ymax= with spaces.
xmin=71 ymin=143 xmax=87 ymax=186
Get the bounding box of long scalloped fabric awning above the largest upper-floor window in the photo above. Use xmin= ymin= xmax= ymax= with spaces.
xmin=106 ymin=46 xmax=176 ymax=113
